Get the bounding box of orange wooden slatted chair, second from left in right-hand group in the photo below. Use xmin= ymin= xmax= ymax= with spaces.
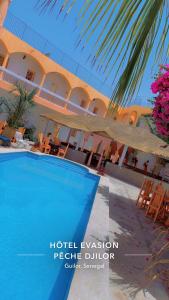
xmin=146 ymin=184 xmax=165 ymax=222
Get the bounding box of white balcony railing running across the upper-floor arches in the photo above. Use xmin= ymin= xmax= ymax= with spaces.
xmin=0 ymin=67 xmax=95 ymax=115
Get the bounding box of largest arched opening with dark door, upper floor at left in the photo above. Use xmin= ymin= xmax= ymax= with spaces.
xmin=4 ymin=52 xmax=44 ymax=89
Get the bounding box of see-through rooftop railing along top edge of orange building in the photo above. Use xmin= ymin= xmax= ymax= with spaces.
xmin=5 ymin=11 xmax=112 ymax=97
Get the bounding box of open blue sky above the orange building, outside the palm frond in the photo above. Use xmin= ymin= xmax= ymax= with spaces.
xmin=5 ymin=0 xmax=161 ymax=105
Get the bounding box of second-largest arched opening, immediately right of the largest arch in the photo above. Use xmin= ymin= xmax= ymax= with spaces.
xmin=40 ymin=72 xmax=71 ymax=106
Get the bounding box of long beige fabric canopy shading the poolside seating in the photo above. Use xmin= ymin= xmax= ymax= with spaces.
xmin=41 ymin=112 xmax=169 ymax=159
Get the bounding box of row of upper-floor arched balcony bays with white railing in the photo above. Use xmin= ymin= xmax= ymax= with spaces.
xmin=0 ymin=39 xmax=107 ymax=116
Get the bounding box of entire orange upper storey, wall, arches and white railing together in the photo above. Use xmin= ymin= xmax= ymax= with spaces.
xmin=0 ymin=20 xmax=147 ymax=124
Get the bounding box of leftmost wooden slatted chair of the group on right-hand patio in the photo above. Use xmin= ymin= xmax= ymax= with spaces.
xmin=136 ymin=179 xmax=154 ymax=208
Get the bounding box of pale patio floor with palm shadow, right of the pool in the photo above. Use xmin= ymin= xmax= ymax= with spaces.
xmin=68 ymin=176 xmax=169 ymax=300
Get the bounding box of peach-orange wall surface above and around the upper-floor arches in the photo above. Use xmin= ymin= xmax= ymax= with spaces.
xmin=0 ymin=28 xmax=151 ymax=124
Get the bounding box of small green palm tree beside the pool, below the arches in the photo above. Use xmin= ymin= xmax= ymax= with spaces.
xmin=0 ymin=82 xmax=37 ymax=128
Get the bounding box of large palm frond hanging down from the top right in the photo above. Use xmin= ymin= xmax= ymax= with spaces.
xmin=38 ymin=0 xmax=169 ymax=105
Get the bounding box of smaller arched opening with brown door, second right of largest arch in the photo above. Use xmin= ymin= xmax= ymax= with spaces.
xmin=68 ymin=87 xmax=90 ymax=113
